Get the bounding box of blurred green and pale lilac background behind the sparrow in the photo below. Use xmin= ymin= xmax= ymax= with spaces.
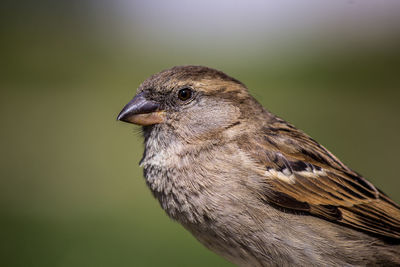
xmin=0 ymin=0 xmax=400 ymax=267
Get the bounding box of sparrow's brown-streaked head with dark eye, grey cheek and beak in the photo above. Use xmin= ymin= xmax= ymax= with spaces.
xmin=118 ymin=66 xmax=262 ymax=142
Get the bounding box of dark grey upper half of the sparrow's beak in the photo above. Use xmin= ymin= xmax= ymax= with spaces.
xmin=117 ymin=92 xmax=160 ymax=123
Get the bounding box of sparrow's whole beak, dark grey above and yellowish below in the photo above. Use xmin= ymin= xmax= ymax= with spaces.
xmin=117 ymin=92 xmax=165 ymax=126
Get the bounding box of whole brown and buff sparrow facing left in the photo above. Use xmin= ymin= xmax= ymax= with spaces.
xmin=118 ymin=66 xmax=400 ymax=266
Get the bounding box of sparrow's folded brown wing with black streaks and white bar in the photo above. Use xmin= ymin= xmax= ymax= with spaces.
xmin=241 ymin=122 xmax=400 ymax=240
